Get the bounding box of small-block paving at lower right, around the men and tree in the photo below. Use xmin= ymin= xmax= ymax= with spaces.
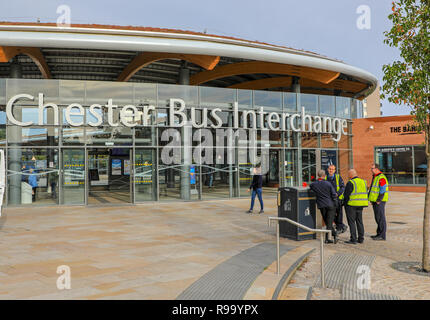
xmin=291 ymin=192 xmax=430 ymax=300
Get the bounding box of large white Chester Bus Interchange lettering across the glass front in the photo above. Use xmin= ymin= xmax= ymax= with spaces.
xmin=6 ymin=93 xmax=348 ymax=141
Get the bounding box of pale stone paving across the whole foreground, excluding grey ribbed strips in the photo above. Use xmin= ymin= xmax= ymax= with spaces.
xmin=0 ymin=192 xmax=430 ymax=299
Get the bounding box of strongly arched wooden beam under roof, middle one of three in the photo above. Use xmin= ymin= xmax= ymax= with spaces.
xmin=117 ymin=52 xmax=220 ymax=81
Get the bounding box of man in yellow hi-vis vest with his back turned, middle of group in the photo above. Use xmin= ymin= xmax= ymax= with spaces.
xmin=343 ymin=169 xmax=369 ymax=244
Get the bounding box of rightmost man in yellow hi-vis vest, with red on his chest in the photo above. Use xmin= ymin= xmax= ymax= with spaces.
xmin=369 ymin=163 xmax=388 ymax=240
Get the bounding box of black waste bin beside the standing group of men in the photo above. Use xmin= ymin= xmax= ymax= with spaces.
xmin=278 ymin=187 xmax=316 ymax=241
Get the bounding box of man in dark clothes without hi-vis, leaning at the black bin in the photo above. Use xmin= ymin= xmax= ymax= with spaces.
xmin=309 ymin=170 xmax=338 ymax=243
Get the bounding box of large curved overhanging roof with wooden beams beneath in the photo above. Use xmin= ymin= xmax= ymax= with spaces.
xmin=0 ymin=22 xmax=378 ymax=98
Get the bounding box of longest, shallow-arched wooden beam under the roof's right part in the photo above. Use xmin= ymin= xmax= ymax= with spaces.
xmin=190 ymin=61 xmax=340 ymax=85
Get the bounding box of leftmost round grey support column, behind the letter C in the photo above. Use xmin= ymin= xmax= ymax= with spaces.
xmin=6 ymin=60 xmax=22 ymax=205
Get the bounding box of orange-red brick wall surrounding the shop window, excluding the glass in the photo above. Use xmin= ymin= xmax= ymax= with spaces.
xmin=352 ymin=116 xmax=425 ymax=192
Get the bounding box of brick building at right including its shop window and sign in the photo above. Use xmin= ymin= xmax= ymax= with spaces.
xmin=352 ymin=115 xmax=427 ymax=192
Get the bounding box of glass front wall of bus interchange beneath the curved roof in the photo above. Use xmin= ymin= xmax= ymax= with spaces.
xmin=0 ymin=79 xmax=356 ymax=206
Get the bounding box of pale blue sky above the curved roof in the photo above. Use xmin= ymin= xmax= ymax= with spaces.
xmin=0 ymin=0 xmax=410 ymax=115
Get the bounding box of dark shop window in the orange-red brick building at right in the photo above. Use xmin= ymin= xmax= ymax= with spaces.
xmin=375 ymin=146 xmax=427 ymax=185
